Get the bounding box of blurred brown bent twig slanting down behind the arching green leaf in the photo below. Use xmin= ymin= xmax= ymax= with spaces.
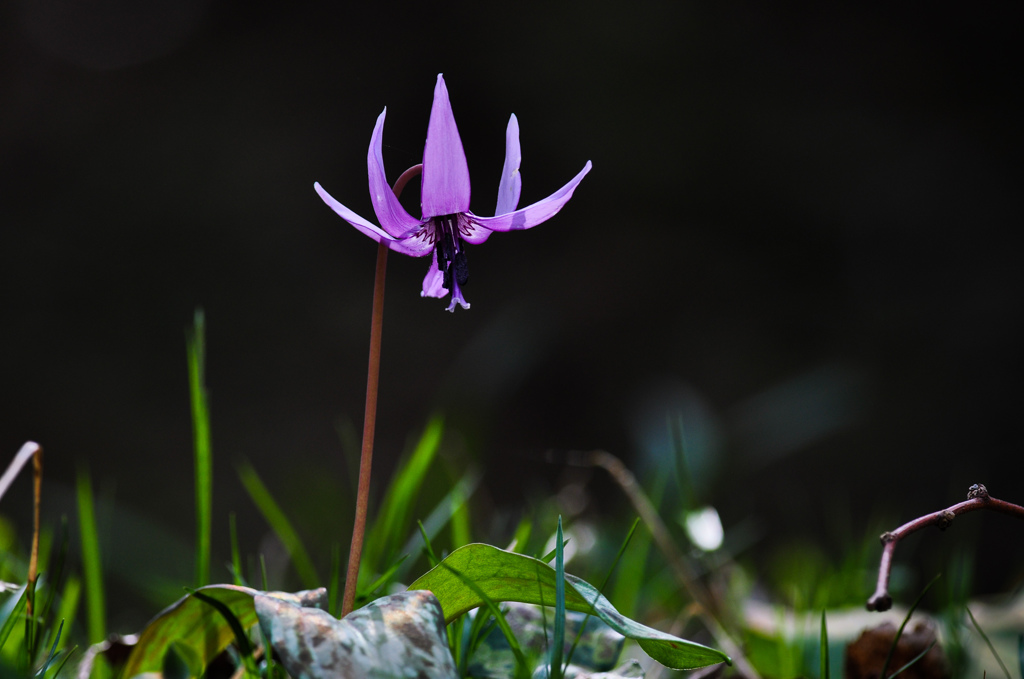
xmin=585 ymin=451 xmax=761 ymax=679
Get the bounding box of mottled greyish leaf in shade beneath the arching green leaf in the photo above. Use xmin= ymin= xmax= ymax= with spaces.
xmin=469 ymin=602 xmax=626 ymax=679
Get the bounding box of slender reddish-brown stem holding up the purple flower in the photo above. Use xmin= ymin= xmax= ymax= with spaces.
xmin=341 ymin=165 xmax=423 ymax=618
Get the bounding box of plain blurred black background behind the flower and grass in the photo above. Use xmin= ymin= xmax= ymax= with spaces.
xmin=0 ymin=0 xmax=1024 ymax=619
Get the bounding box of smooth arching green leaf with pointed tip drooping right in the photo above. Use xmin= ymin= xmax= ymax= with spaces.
xmin=409 ymin=544 xmax=731 ymax=670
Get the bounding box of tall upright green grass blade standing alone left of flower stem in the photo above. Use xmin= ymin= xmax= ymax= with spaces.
xmin=185 ymin=308 xmax=213 ymax=587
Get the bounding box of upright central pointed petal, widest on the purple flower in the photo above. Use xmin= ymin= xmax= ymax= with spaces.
xmin=420 ymin=74 xmax=470 ymax=220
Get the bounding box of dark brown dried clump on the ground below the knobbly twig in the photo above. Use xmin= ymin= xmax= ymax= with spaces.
xmin=846 ymin=621 xmax=951 ymax=679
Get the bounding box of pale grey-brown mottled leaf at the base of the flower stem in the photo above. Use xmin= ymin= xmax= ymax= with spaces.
xmin=256 ymin=592 xmax=458 ymax=679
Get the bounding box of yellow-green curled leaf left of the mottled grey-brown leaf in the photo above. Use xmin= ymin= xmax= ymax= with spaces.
xmin=121 ymin=585 xmax=327 ymax=677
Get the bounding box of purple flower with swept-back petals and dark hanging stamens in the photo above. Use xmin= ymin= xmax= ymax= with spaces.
xmin=313 ymin=75 xmax=591 ymax=311
